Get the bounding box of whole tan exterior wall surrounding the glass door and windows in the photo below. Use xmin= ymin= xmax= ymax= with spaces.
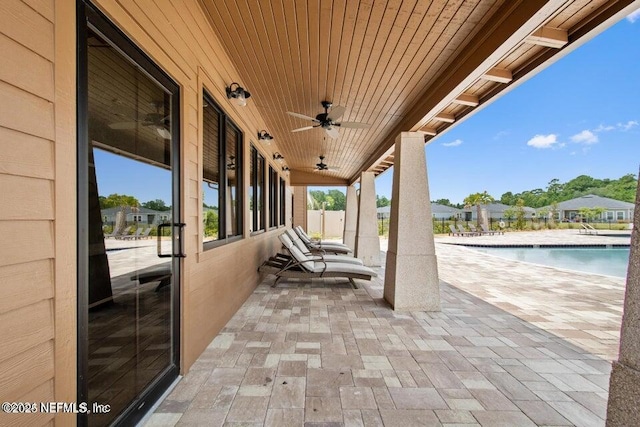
xmin=0 ymin=0 xmax=292 ymax=426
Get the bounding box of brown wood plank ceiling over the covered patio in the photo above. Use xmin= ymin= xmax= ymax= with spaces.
xmin=200 ymin=0 xmax=640 ymax=185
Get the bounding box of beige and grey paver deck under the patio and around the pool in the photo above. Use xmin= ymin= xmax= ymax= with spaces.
xmin=146 ymin=231 xmax=624 ymax=427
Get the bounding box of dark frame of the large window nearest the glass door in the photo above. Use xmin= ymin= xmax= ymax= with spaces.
xmin=200 ymin=90 xmax=244 ymax=252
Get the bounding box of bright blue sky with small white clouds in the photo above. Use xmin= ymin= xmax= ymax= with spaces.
xmin=376 ymin=15 xmax=640 ymax=203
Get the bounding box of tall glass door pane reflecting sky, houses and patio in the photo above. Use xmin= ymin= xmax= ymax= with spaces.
xmin=79 ymin=5 xmax=180 ymax=426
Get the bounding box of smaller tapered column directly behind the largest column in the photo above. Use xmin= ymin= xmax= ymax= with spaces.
xmin=354 ymin=172 xmax=380 ymax=267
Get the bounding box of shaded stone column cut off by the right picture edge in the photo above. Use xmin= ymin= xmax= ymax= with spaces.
xmin=607 ymin=174 xmax=640 ymax=427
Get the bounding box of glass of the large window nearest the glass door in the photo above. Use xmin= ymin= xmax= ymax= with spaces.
xmin=202 ymin=91 xmax=242 ymax=249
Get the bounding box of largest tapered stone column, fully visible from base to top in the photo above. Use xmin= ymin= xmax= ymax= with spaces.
xmin=384 ymin=132 xmax=440 ymax=311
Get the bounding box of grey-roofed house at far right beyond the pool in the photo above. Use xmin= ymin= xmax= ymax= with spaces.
xmin=544 ymin=194 xmax=635 ymax=222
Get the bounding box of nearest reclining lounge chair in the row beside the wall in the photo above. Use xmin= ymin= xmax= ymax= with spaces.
xmin=258 ymin=239 xmax=377 ymax=289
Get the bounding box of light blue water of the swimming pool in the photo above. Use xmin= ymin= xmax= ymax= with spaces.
xmin=473 ymin=248 xmax=629 ymax=277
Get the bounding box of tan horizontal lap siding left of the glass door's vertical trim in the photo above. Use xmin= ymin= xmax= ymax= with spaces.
xmin=0 ymin=0 xmax=59 ymax=426
